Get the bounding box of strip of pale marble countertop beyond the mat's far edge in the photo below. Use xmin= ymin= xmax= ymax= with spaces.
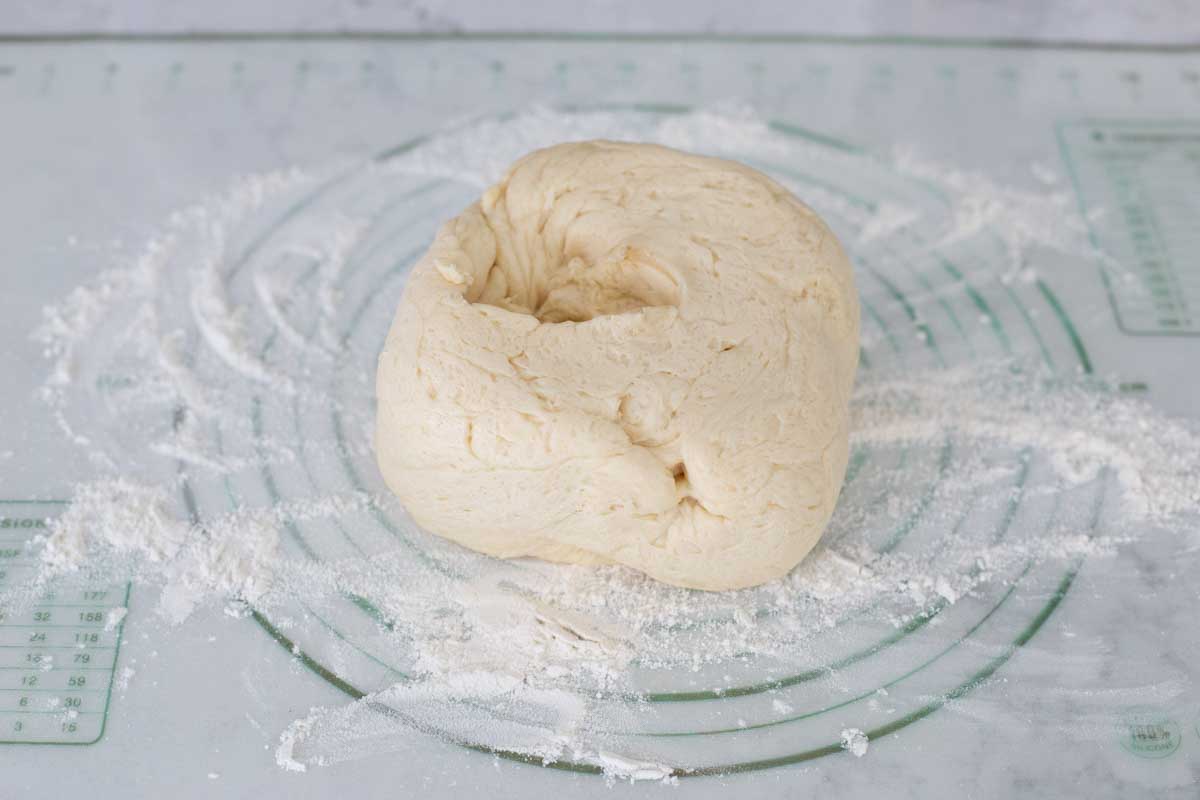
xmin=7 ymin=0 xmax=1200 ymax=43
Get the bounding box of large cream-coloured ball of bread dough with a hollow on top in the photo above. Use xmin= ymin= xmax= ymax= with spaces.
xmin=376 ymin=142 xmax=859 ymax=590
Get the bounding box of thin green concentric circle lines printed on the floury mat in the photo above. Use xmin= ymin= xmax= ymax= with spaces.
xmin=171 ymin=104 xmax=1104 ymax=777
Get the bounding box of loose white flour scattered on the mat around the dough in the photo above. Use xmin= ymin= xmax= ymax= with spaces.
xmin=18 ymin=109 xmax=1200 ymax=780
